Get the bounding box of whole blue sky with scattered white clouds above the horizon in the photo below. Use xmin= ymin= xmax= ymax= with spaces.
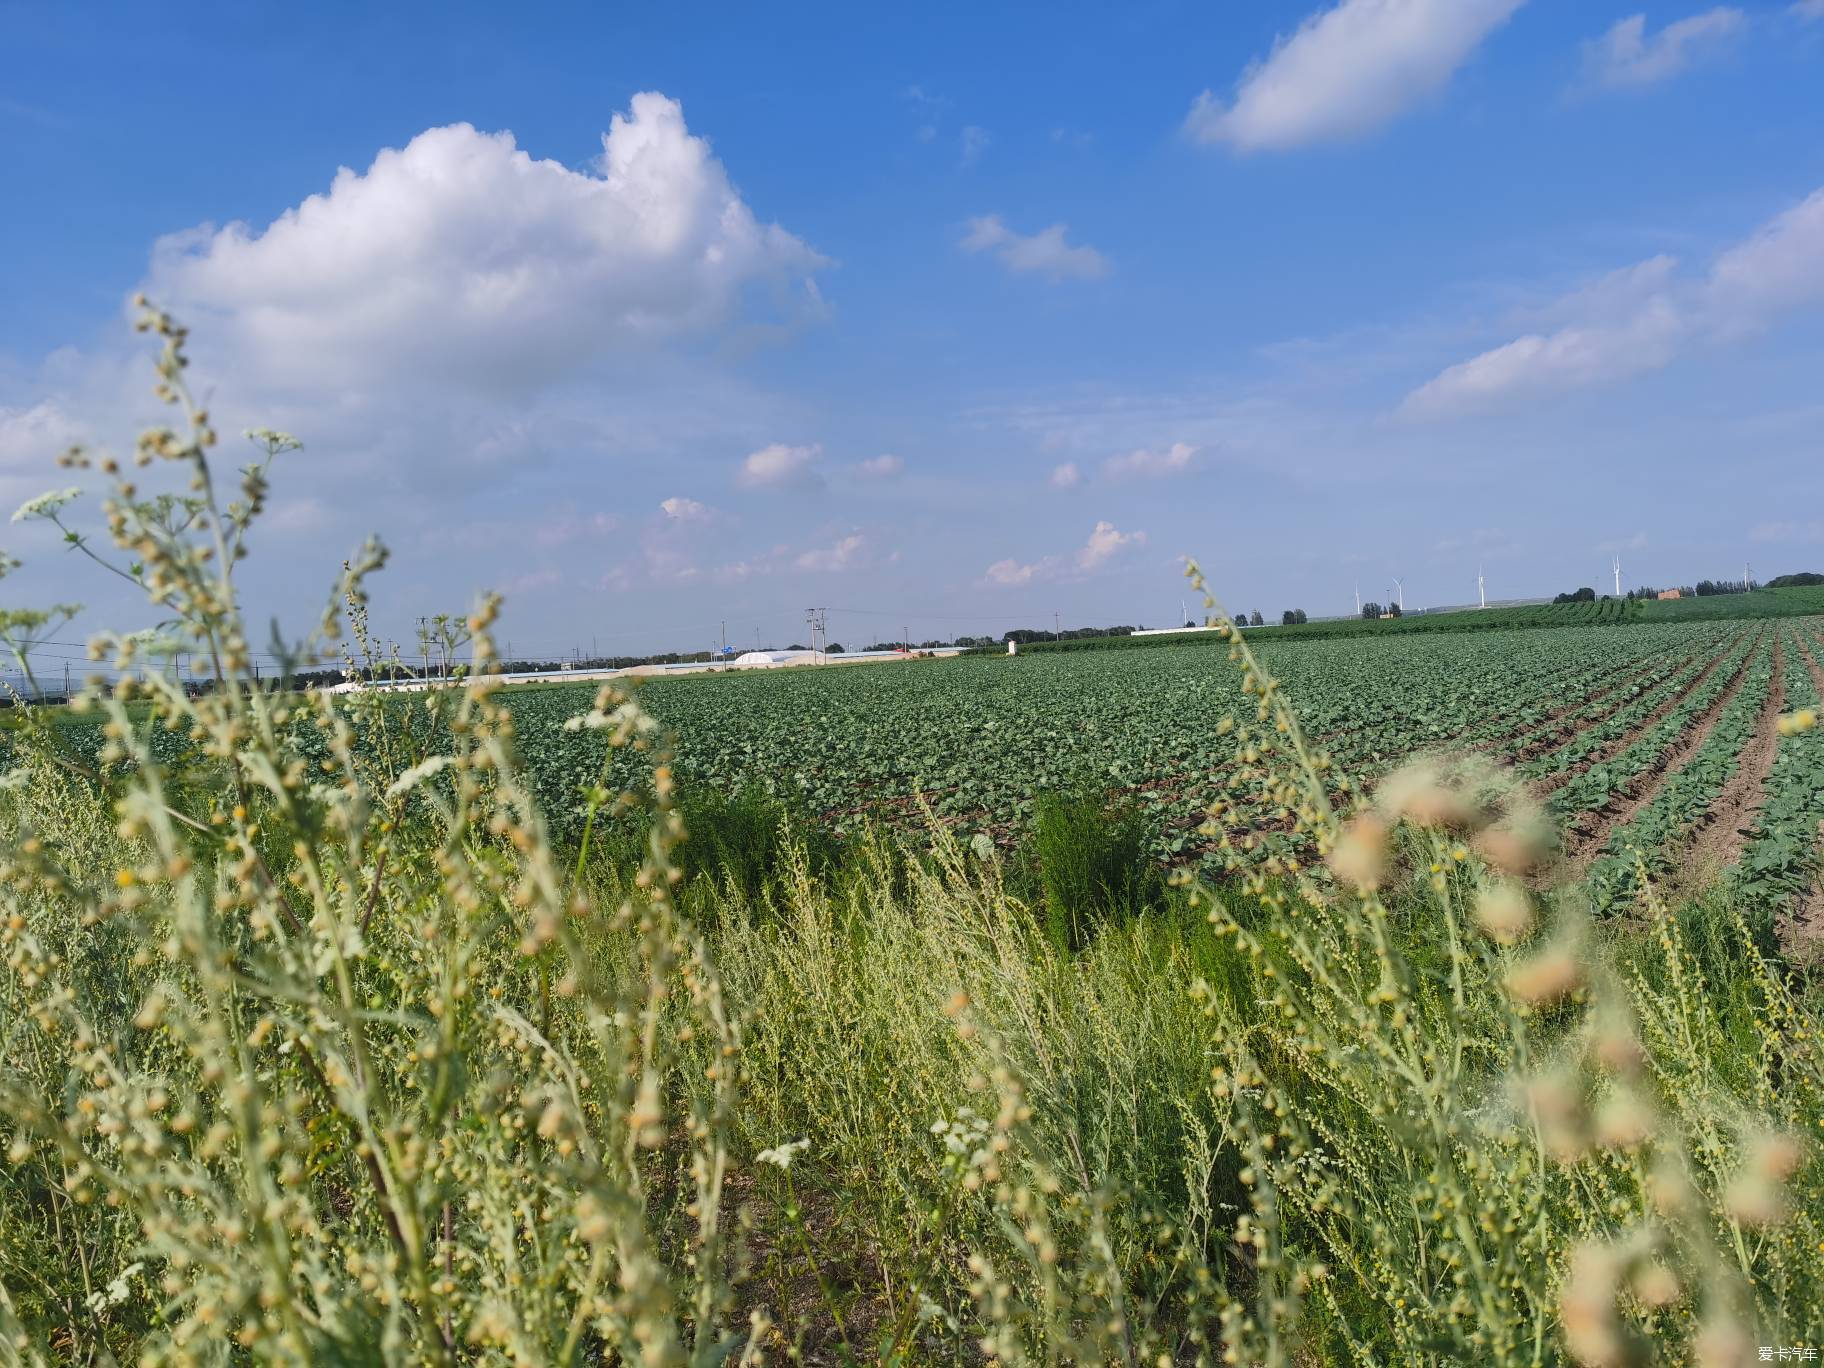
xmin=0 ymin=0 xmax=1824 ymax=655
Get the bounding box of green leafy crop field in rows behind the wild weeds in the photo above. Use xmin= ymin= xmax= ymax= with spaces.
xmin=485 ymin=620 xmax=1824 ymax=915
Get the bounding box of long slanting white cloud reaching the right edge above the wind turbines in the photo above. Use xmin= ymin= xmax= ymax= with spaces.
xmin=1401 ymin=190 xmax=1824 ymax=418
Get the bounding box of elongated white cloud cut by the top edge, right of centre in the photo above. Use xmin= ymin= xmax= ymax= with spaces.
xmin=1184 ymin=0 xmax=1525 ymax=151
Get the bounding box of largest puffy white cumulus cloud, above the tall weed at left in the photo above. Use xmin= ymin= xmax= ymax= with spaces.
xmin=148 ymin=93 xmax=824 ymax=390
